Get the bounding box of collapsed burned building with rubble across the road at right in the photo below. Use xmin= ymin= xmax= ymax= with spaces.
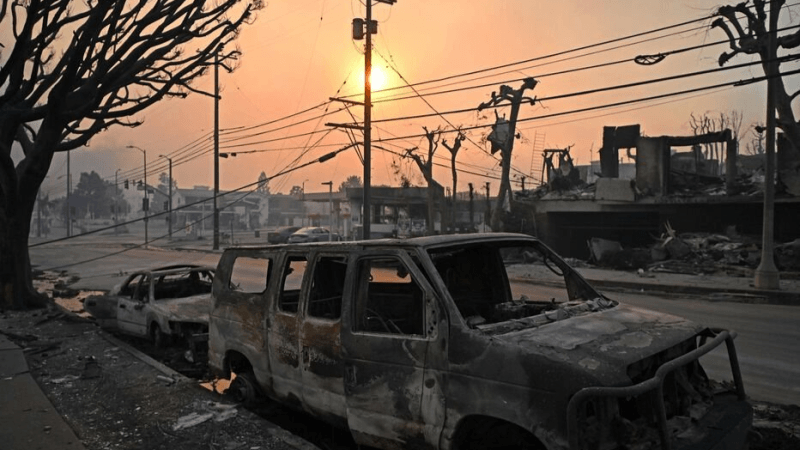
xmin=514 ymin=125 xmax=800 ymax=259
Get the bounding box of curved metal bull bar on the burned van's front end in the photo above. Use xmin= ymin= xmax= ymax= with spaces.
xmin=567 ymin=329 xmax=745 ymax=450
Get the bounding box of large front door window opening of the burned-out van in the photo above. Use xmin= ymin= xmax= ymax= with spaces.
xmin=354 ymin=258 xmax=425 ymax=336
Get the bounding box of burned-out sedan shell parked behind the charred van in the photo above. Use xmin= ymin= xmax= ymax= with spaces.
xmin=83 ymin=265 xmax=214 ymax=350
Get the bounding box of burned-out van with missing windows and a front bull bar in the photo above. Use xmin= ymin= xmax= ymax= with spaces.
xmin=209 ymin=233 xmax=752 ymax=450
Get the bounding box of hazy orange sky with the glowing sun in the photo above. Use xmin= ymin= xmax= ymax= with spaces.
xmin=36 ymin=0 xmax=797 ymax=197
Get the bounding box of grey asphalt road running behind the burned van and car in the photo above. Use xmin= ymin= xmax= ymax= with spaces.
xmin=30 ymin=242 xmax=800 ymax=405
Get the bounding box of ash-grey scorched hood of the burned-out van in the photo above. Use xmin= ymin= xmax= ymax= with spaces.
xmin=493 ymin=304 xmax=704 ymax=385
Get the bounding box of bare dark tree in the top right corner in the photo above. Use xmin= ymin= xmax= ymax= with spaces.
xmin=712 ymin=0 xmax=800 ymax=151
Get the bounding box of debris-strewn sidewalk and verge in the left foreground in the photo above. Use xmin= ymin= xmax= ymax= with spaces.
xmin=0 ymin=308 xmax=319 ymax=450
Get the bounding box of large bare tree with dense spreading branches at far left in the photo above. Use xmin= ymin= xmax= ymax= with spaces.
xmin=0 ymin=0 xmax=263 ymax=308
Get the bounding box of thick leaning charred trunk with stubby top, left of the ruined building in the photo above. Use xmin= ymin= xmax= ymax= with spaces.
xmin=478 ymin=77 xmax=538 ymax=231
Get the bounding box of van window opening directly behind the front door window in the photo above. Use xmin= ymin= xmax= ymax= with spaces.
xmin=307 ymin=256 xmax=347 ymax=320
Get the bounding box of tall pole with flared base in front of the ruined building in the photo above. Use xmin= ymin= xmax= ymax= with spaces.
xmin=753 ymin=0 xmax=782 ymax=290
